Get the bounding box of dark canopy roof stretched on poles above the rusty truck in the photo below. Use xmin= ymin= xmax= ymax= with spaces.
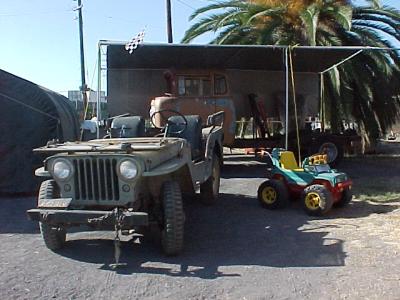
xmin=107 ymin=44 xmax=366 ymax=73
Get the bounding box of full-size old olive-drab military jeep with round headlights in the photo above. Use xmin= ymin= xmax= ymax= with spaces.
xmin=27 ymin=110 xmax=224 ymax=255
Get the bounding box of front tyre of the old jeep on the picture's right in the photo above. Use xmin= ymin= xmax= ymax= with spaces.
xmin=161 ymin=181 xmax=185 ymax=255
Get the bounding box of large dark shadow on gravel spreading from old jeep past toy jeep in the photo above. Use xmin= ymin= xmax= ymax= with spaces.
xmin=55 ymin=194 xmax=394 ymax=279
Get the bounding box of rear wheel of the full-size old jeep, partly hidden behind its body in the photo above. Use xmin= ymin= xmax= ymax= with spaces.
xmin=200 ymin=154 xmax=221 ymax=205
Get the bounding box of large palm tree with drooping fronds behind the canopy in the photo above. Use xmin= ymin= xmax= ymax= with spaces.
xmin=182 ymin=0 xmax=400 ymax=149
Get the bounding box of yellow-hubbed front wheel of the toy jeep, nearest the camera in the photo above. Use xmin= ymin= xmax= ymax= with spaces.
xmin=302 ymin=184 xmax=333 ymax=216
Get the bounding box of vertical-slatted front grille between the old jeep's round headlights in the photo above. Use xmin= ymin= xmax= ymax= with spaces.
xmin=73 ymin=157 xmax=119 ymax=201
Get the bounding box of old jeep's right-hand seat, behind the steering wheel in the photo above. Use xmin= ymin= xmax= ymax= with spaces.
xmin=168 ymin=115 xmax=203 ymax=160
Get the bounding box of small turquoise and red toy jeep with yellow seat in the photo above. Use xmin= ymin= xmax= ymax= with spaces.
xmin=257 ymin=148 xmax=352 ymax=216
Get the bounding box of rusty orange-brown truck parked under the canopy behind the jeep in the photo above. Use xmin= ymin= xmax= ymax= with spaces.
xmin=150 ymin=70 xmax=359 ymax=164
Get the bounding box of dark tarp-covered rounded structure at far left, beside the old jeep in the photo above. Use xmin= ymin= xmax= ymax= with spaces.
xmin=0 ymin=70 xmax=79 ymax=194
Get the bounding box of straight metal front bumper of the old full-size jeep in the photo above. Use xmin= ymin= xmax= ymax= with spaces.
xmin=27 ymin=208 xmax=149 ymax=229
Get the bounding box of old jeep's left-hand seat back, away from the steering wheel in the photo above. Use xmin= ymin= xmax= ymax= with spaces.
xmin=111 ymin=116 xmax=145 ymax=138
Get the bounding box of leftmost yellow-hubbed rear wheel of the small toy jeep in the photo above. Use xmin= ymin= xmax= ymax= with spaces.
xmin=257 ymin=179 xmax=289 ymax=209
